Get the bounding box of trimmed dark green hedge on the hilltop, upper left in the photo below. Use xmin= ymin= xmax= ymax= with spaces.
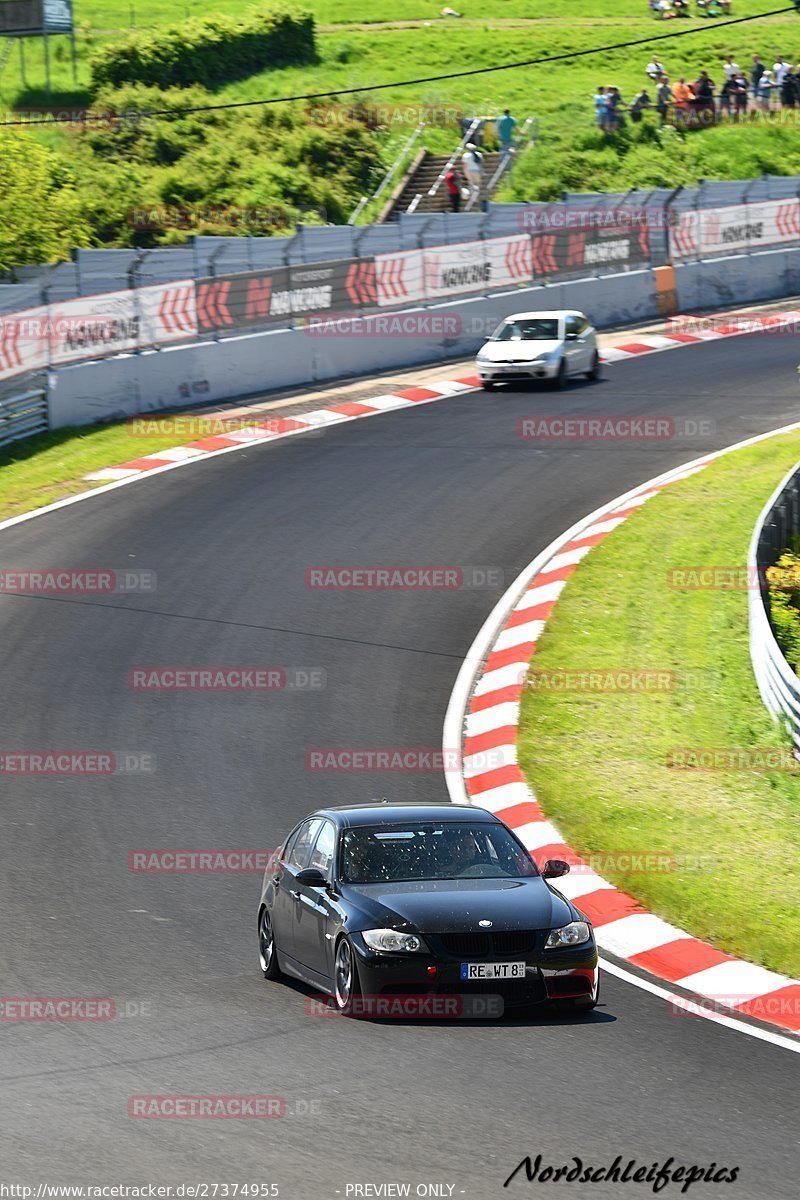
xmin=90 ymin=10 xmax=317 ymax=94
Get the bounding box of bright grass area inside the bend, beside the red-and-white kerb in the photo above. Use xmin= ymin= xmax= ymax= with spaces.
xmin=519 ymin=433 xmax=800 ymax=978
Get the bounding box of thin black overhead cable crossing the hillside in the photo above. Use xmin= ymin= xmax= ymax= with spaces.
xmin=0 ymin=0 xmax=800 ymax=128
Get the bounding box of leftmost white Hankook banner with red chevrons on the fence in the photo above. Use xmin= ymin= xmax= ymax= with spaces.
xmin=0 ymin=280 xmax=198 ymax=379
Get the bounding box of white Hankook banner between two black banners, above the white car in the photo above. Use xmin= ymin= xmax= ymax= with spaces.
xmin=375 ymin=234 xmax=533 ymax=306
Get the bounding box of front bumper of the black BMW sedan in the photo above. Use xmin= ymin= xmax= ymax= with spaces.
xmin=351 ymin=934 xmax=597 ymax=1008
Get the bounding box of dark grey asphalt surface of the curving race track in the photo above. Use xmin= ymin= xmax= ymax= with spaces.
xmin=0 ymin=337 xmax=800 ymax=1200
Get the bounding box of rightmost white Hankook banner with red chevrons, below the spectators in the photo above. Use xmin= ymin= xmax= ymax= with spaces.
xmin=669 ymin=199 xmax=800 ymax=260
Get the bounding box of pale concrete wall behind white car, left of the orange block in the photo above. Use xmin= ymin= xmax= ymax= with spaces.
xmin=49 ymin=269 xmax=656 ymax=428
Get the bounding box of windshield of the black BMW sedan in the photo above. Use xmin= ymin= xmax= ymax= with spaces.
xmin=341 ymin=821 xmax=539 ymax=883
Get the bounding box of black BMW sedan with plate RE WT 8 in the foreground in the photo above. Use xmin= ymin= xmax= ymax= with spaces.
xmin=258 ymin=802 xmax=600 ymax=1015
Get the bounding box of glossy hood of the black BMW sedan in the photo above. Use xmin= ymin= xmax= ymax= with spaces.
xmin=347 ymin=876 xmax=575 ymax=934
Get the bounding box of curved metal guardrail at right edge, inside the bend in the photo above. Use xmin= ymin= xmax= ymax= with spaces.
xmin=747 ymin=464 xmax=800 ymax=754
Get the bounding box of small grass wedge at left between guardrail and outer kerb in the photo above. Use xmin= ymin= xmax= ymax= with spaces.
xmin=0 ymin=418 xmax=209 ymax=520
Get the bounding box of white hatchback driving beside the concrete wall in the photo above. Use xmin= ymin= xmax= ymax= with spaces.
xmin=476 ymin=308 xmax=600 ymax=391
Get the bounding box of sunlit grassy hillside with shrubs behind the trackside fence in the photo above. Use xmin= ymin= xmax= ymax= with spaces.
xmin=0 ymin=0 xmax=800 ymax=265
